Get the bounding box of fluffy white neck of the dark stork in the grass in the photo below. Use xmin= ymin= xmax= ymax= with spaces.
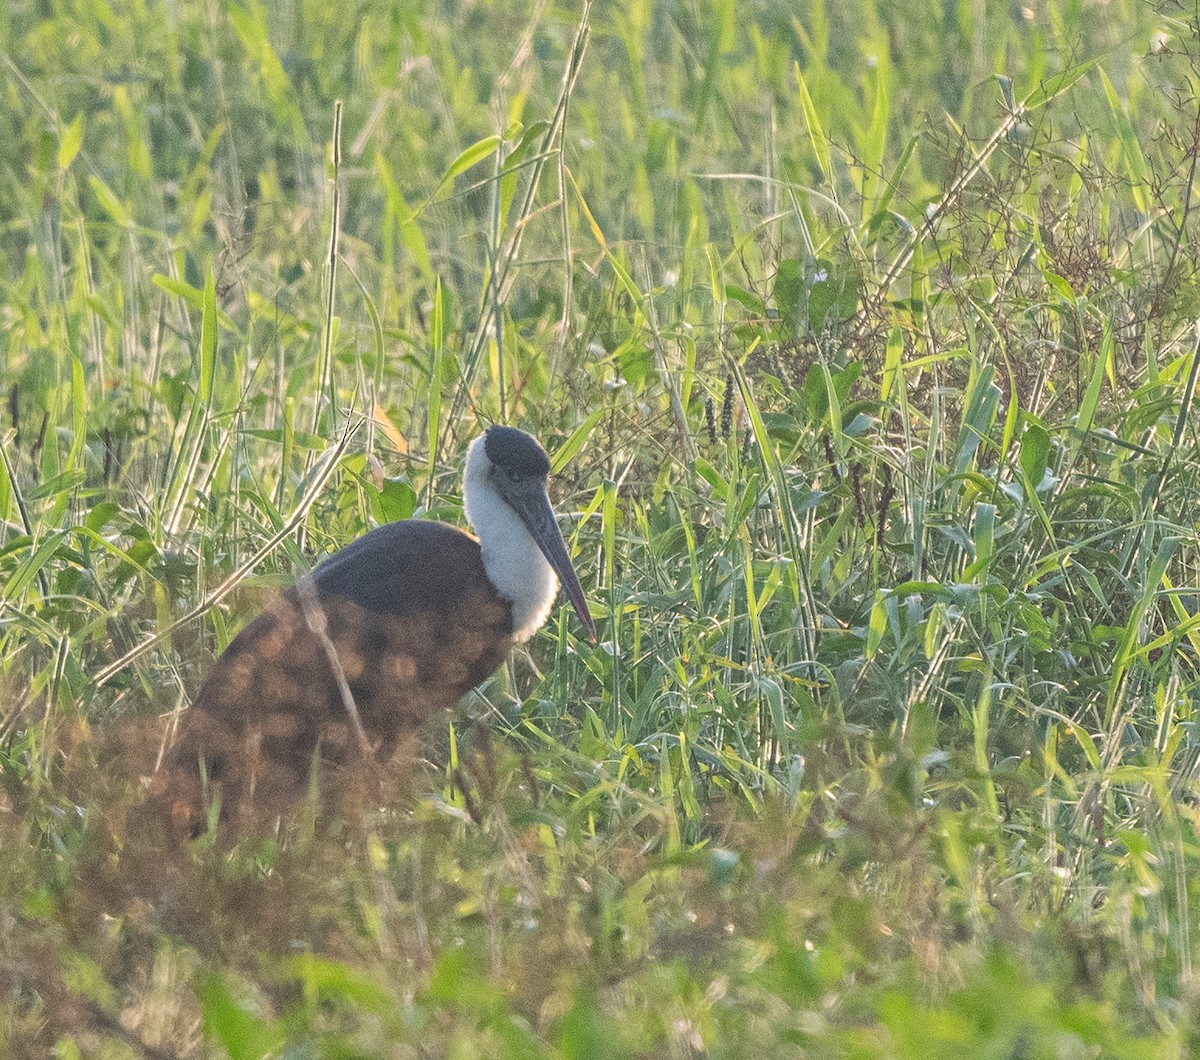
xmin=462 ymin=436 xmax=558 ymax=643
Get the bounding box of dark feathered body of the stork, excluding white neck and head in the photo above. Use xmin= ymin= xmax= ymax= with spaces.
xmin=155 ymin=520 xmax=511 ymax=833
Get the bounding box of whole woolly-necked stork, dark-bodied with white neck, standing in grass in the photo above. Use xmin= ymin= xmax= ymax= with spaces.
xmin=150 ymin=425 xmax=596 ymax=838
